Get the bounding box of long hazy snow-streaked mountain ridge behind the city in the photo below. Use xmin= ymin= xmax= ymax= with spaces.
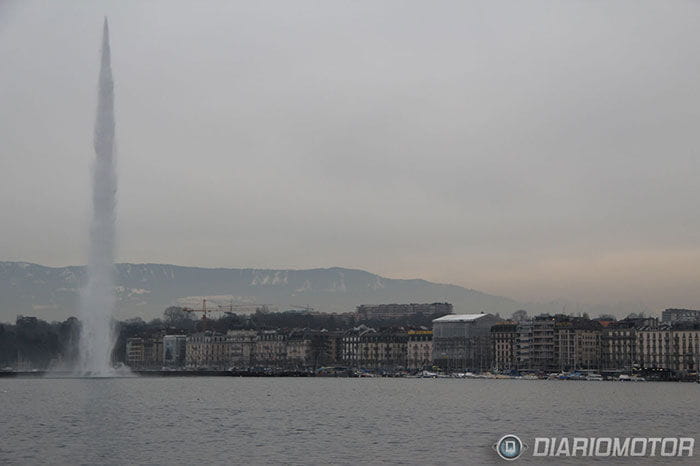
xmin=0 ymin=262 xmax=522 ymax=321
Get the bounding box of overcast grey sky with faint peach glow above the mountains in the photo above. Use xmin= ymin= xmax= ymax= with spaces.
xmin=0 ymin=0 xmax=700 ymax=308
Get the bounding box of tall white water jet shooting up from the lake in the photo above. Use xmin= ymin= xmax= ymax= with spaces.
xmin=78 ymin=18 xmax=117 ymax=376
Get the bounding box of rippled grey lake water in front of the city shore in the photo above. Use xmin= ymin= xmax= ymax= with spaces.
xmin=0 ymin=377 xmax=700 ymax=465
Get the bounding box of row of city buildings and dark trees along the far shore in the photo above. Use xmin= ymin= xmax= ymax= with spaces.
xmin=0 ymin=303 xmax=700 ymax=382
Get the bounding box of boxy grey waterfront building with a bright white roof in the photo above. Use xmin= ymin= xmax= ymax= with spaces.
xmin=433 ymin=313 xmax=499 ymax=372
